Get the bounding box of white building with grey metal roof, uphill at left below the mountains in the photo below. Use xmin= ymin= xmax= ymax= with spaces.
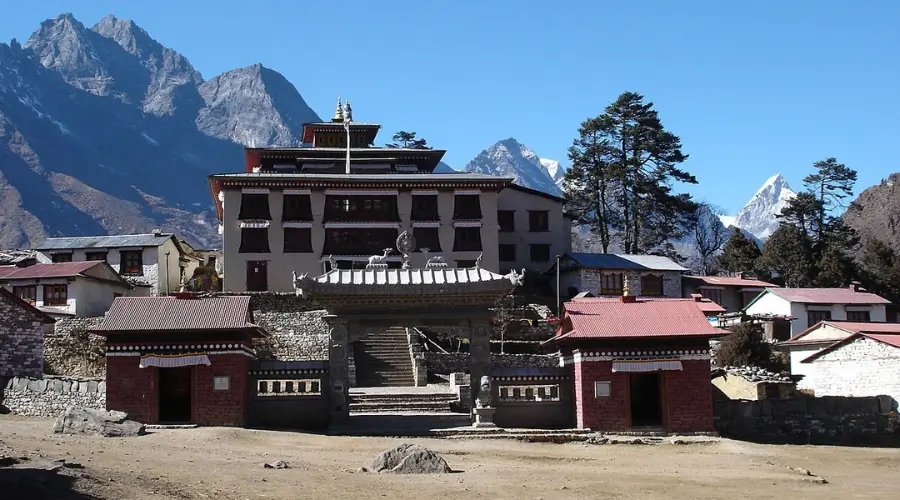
xmin=35 ymin=231 xmax=201 ymax=295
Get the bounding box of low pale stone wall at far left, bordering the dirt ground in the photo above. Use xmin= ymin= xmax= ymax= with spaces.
xmin=0 ymin=376 xmax=106 ymax=417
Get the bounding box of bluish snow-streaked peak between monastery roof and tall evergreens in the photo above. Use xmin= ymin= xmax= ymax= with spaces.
xmin=463 ymin=137 xmax=562 ymax=196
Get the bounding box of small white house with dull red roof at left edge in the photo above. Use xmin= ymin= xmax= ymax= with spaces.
xmin=0 ymin=261 xmax=142 ymax=317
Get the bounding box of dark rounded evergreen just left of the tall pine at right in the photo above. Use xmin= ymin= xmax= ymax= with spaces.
xmin=760 ymin=224 xmax=815 ymax=288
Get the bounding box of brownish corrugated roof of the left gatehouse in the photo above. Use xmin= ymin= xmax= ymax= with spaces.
xmin=96 ymin=296 xmax=253 ymax=332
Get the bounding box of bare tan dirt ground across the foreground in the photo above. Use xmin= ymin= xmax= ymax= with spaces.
xmin=0 ymin=415 xmax=900 ymax=500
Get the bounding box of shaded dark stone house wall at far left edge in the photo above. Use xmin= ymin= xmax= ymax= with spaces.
xmin=0 ymin=295 xmax=44 ymax=377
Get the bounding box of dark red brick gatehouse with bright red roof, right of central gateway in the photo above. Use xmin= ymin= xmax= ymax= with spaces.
xmin=552 ymin=296 xmax=727 ymax=432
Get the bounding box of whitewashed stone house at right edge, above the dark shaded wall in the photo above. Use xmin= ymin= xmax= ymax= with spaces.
xmin=791 ymin=323 xmax=900 ymax=408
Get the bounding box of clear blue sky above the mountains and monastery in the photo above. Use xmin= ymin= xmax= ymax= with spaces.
xmin=0 ymin=0 xmax=900 ymax=214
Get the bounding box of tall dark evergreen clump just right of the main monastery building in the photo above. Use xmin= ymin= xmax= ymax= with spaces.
xmin=566 ymin=92 xmax=697 ymax=253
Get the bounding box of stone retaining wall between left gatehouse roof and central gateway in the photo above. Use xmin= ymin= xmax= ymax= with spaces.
xmin=253 ymin=310 xmax=331 ymax=361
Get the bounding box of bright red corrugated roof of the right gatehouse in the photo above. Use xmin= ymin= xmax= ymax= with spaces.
xmin=556 ymin=299 xmax=728 ymax=339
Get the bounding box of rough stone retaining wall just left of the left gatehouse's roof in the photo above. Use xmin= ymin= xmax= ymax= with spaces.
xmin=44 ymin=316 xmax=106 ymax=378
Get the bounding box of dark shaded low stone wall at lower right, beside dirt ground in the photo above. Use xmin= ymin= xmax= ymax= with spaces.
xmin=715 ymin=396 xmax=900 ymax=446
